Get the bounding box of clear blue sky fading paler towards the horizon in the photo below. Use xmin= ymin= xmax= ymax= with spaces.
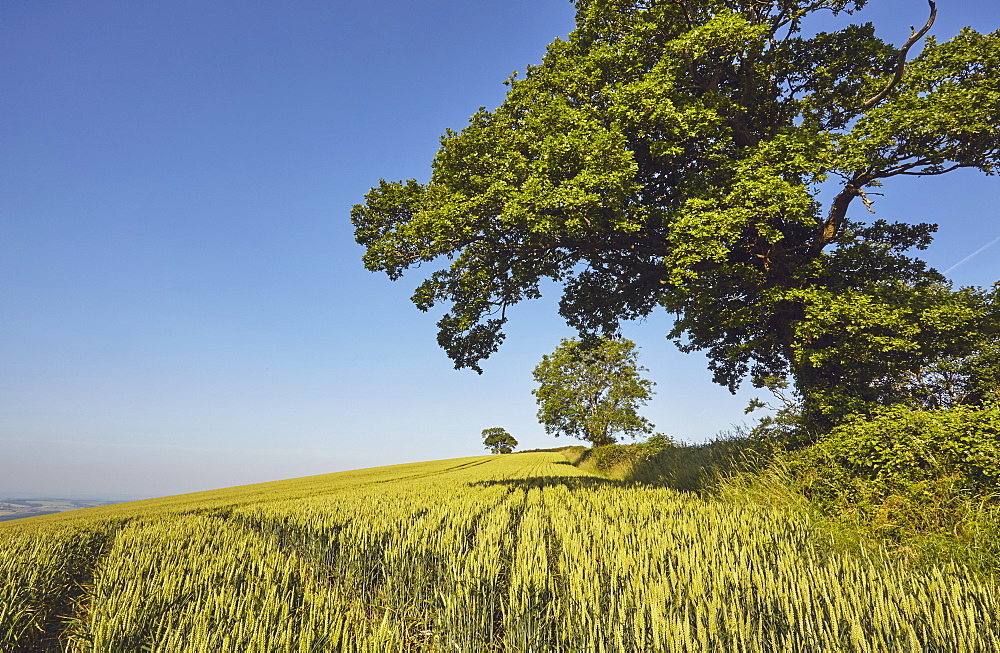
xmin=0 ymin=0 xmax=1000 ymax=496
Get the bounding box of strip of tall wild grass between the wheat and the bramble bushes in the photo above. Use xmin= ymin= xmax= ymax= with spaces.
xmin=584 ymin=429 xmax=1000 ymax=578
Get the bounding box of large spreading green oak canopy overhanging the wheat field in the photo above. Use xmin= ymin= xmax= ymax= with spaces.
xmin=352 ymin=0 xmax=1000 ymax=426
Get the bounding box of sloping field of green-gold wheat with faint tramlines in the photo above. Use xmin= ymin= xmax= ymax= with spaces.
xmin=0 ymin=452 xmax=1000 ymax=652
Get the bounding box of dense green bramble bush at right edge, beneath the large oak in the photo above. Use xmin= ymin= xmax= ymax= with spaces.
xmin=784 ymin=404 xmax=1000 ymax=555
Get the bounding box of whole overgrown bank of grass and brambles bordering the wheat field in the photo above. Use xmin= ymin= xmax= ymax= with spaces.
xmin=567 ymin=408 xmax=1000 ymax=575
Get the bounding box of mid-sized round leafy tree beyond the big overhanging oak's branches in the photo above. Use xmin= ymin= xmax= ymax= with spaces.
xmin=532 ymin=338 xmax=654 ymax=446
